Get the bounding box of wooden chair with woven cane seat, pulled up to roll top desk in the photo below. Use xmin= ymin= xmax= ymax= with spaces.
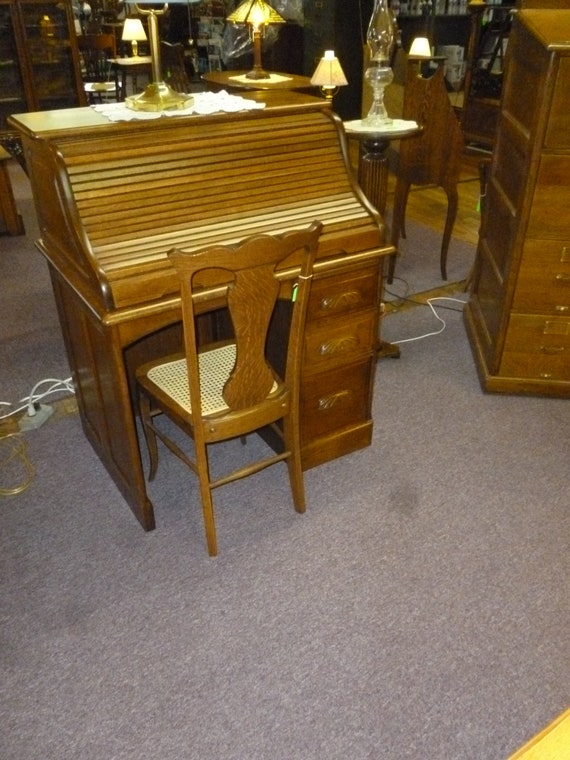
xmin=136 ymin=222 xmax=322 ymax=556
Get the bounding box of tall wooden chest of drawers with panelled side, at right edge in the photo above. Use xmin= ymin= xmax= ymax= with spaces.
xmin=465 ymin=9 xmax=570 ymax=396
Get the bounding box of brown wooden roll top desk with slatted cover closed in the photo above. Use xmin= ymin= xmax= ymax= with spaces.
xmin=11 ymin=92 xmax=393 ymax=530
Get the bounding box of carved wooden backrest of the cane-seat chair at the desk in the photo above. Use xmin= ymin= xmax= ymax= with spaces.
xmin=168 ymin=222 xmax=322 ymax=411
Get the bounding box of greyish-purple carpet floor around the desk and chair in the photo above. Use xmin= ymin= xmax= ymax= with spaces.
xmin=0 ymin=159 xmax=570 ymax=760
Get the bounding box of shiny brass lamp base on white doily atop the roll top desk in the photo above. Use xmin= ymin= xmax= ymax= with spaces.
xmin=125 ymin=0 xmax=194 ymax=111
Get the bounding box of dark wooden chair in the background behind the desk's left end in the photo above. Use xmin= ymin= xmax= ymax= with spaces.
xmin=77 ymin=34 xmax=121 ymax=103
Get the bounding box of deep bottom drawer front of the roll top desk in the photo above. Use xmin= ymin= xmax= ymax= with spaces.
xmin=301 ymin=359 xmax=374 ymax=441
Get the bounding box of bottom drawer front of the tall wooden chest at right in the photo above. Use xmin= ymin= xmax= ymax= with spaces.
xmin=500 ymin=314 xmax=570 ymax=380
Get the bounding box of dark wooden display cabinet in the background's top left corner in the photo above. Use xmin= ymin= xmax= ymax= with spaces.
xmin=0 ymin=0 xmax=86 ymax=133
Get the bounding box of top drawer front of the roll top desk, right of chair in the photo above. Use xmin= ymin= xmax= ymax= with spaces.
xmin=307 ymin=265 xmax=379 ymax=321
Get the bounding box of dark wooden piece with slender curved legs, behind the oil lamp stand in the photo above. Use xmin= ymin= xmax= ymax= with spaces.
xmin=387 ymin=62 xmax=464 ymax=283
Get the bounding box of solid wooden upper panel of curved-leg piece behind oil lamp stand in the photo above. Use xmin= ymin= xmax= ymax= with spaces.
xmin=398 ymin=62 xmax=464 ymax=187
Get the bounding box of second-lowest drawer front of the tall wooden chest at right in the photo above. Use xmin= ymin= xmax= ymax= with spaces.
xmin=513 ymin=238 xmax=570 ymax=317
